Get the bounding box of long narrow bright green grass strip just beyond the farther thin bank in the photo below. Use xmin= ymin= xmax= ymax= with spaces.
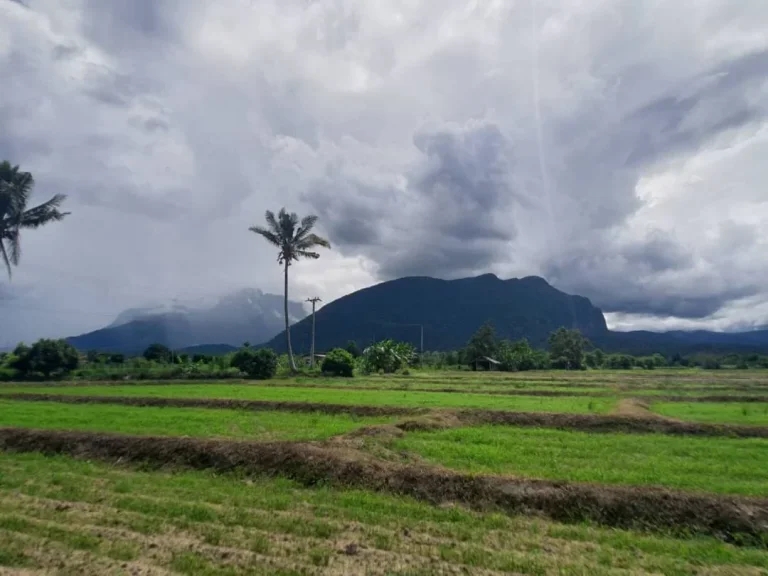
xmin=0 ymin=384 xmax=616 ymax=413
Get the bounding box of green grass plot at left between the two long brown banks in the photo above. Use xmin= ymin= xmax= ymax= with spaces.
xmin=0 ymin=400 xmax=392 ymax=440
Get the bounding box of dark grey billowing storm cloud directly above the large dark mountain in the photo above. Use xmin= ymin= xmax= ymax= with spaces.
xmin=305 ymin=121 xmax=517 ymax=278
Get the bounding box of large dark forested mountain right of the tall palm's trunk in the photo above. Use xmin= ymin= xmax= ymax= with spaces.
xmin=266 ymin=274 xmax=608 ymax=353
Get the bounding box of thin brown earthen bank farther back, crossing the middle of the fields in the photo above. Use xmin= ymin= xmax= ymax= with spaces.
xmin=6 ymin=394 xmax=768 ymax=438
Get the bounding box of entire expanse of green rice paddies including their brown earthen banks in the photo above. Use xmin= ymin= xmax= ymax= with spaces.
xmin=0 ymin=370 xmax=768 ymax=576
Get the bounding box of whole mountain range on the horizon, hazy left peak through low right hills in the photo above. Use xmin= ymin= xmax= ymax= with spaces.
xmin=68 ymin=274 xmax=768 ymax=355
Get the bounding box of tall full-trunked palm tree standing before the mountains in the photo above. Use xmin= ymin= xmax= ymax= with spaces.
xmin=249 ymin=208 xmax=331 ymax=372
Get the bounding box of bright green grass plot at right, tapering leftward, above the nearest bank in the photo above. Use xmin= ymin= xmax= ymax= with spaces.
xmin=395 ymin=426 xmax=768 ymax=496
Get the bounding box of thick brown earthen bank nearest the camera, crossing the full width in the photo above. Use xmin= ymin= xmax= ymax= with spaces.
xmin=0 ymin=428 xmax=768 ymax=547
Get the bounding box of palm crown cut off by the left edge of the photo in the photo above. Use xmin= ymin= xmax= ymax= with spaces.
xmin=0 ymin=160 xmax=69 ymax=278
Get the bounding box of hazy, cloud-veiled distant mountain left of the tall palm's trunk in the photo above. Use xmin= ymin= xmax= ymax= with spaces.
xmin=67 ymin=289 xmax=306 ymax=354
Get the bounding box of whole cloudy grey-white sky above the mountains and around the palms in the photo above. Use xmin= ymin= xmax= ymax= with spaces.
xmin=0 ymin=0 xmax=768 ymax=347
